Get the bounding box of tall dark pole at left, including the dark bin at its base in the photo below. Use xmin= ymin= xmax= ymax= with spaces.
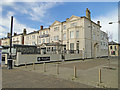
xmin=7 ymin=16 xmax=13 ymax=69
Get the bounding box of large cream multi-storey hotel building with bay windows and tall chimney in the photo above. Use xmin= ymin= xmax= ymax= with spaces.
xmin=1 ymin=8 xmax=108 ymax=58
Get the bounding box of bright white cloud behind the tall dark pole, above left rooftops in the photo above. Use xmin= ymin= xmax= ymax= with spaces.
xmin=0 ymin=11 xmax=35 ymax=38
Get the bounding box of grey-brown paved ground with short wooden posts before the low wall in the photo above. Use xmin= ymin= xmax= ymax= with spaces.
xmin=2 ymin=58 xmax=118 ymax=88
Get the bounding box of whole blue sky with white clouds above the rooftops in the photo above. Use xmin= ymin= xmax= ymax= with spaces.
xmin=0 ymin=2 xmax=118 ymax=41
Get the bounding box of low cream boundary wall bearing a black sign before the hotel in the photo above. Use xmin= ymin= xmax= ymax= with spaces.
xmin=15 ymin=52 xmax=82 ymax=66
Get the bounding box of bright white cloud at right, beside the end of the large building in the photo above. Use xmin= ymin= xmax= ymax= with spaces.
xmin=93 ymin=10 xmax=118 ymax=41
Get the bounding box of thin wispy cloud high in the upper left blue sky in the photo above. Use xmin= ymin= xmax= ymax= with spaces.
xmin=4 ymin=2 xmax=60 ymax=21
